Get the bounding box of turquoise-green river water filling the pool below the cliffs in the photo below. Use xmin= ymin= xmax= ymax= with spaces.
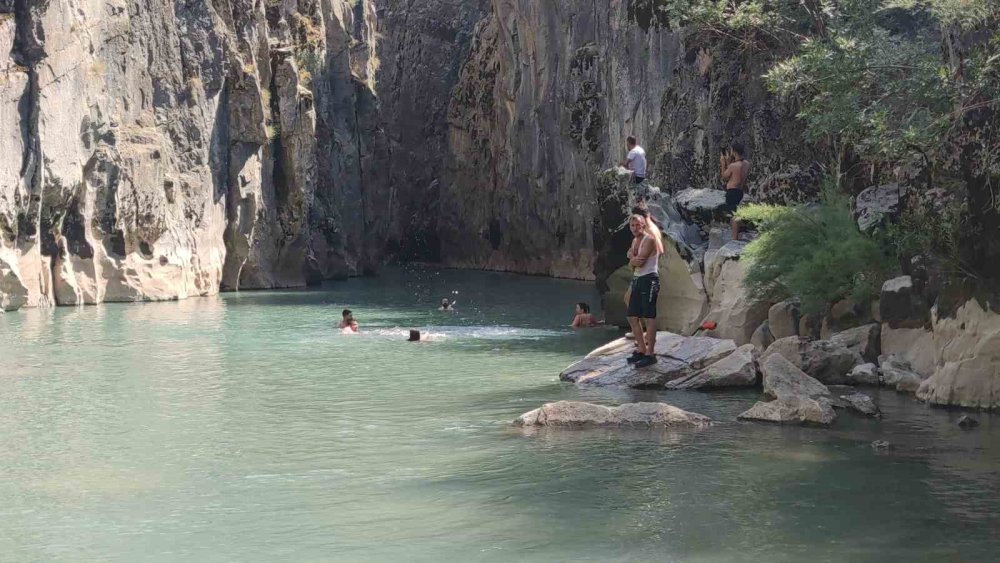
xmin=0 ymin=269 xmax=1000 ymax=562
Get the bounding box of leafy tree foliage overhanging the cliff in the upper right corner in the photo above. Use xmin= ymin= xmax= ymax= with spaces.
xmin=644 ymin=0 xmax=1000 ymax=282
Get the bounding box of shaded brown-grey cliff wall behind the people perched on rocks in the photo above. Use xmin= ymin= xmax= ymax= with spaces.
xmin=439 ymin=0 xmax=808 ymax=279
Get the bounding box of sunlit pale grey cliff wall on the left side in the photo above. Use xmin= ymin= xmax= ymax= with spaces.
xmin=0 ymin=0 xmax=388 ymax=305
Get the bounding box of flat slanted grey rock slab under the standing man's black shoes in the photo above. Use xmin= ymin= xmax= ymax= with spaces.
xmin=559 ymin=332 xmax=736 ymax=389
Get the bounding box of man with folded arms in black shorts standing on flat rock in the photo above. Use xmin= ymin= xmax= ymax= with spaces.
xmin=627 ymin=214 xmax=663 ymax=368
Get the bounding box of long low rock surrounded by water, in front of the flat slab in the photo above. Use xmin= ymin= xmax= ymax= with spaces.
xmin=514 ymin=401 xmax=712 ymax=428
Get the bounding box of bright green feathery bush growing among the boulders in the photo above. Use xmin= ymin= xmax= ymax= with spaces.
xmin=737 ymin=189 xmax=891 ymax=313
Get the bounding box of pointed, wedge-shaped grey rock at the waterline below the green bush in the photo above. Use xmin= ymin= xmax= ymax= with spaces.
xmin=739 ymin=354 xmax=837 ymax=426
